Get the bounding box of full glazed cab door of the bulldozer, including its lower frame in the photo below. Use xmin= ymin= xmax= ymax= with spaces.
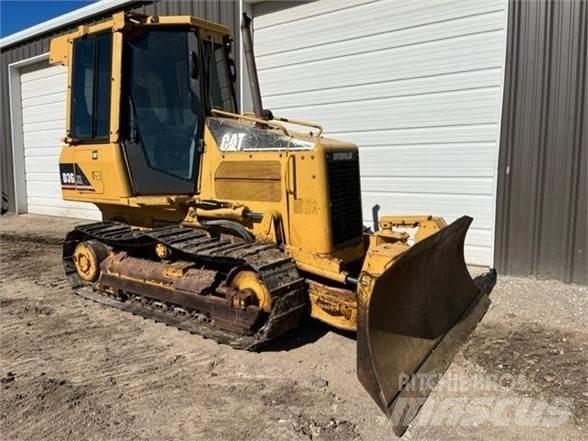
xmin=121 ymin=28 xmax=203 ymax=195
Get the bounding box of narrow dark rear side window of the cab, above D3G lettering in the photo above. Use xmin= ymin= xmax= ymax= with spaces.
xmin=70 ymin=33 xmax=112 ymax=141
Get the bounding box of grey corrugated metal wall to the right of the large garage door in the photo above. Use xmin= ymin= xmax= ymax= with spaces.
xmin=496 ymin=0 xmax=588 ymax=283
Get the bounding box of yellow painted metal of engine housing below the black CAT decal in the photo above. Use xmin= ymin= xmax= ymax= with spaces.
xmin=198 ymin=120 xmax=362 ymax=259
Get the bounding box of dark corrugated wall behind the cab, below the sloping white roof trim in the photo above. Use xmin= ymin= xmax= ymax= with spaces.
xmin=0 ymin=0 xmax=240 ymax=211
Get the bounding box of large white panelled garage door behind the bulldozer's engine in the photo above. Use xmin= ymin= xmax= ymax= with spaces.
xmin=253 ymin=0 xmax=506 ymax=265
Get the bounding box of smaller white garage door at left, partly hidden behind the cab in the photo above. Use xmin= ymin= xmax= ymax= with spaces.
xmin=20 ymin=62 xmax=101 ymax=219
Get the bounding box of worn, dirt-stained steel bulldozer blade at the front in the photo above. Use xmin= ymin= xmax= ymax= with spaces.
xmin=357 ymin=216 xmax=496 ymax=436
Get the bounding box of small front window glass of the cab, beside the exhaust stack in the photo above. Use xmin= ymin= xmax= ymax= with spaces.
xmin=204 ymin=39 xmax=235 ymax=112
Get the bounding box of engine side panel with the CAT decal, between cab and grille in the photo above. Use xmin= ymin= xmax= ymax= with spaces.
xmin=199 ymin=118 xmax=361 ymax=254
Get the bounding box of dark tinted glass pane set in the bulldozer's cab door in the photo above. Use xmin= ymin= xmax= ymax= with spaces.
xmin=125 ymin=30 xmax=200 ymax=181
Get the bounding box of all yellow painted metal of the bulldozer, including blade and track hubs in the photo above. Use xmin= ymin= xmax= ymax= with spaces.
xmin=50 ymin=13 xmax=488 ymax=434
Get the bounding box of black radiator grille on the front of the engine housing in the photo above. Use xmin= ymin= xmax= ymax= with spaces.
xmin=327 ymin=152 xmax=363 ymax=246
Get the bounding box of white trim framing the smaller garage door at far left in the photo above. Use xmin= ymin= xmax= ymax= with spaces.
xmin=8 ymin=52 xmax=49 ymax=214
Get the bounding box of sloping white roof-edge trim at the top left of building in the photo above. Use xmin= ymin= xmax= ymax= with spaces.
xmin=0 ymin=0 xmax=137 ymax=49
